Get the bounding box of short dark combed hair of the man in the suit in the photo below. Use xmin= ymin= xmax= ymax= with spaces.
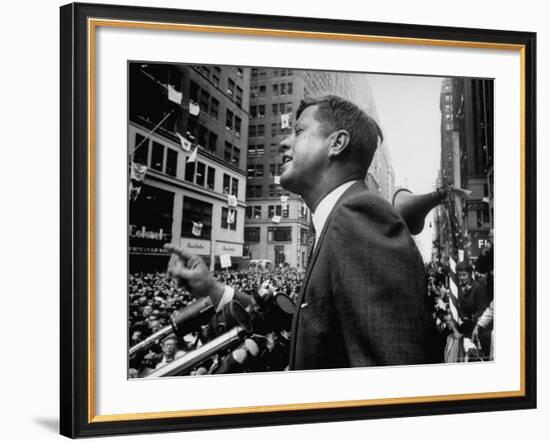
xmin=296 ymin=95 xmax=384 ymax=173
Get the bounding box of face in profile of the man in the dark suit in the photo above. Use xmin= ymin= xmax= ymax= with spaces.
xmin=280 ymin=105 xmax=328 ymax=194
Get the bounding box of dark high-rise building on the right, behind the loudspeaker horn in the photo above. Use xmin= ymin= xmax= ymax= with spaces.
xmin=435 ymin=78 xmax=494 ymax=260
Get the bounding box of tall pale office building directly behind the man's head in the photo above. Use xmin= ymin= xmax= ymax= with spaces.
xmin=245 ymin=68 xmax=395 ymax=268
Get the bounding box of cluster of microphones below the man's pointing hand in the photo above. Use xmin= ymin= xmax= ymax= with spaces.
xmin=129 ymin=281 xmax=295 ymax=378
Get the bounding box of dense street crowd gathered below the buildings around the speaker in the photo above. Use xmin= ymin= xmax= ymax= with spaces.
xmin=129 ymin=241 xmax=493 ymax=377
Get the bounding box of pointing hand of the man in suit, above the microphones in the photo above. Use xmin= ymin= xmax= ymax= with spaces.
xmin=164 ymin=244 xmax=224 ymax=305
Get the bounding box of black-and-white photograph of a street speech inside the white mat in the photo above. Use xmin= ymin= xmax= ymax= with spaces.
xmin=128 ymin=60 xmax=497 ymax=379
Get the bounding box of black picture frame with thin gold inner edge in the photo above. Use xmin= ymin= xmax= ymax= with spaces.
xmin=60 ymin=4 xmax=537 ymax=438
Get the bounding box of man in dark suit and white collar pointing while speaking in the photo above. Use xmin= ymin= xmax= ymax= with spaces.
xmin=166 ymin=95 xmax=438 ymax=370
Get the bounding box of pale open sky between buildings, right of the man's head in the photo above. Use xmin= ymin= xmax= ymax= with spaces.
xmin=368 ymin=74 xmax=443 ymax=261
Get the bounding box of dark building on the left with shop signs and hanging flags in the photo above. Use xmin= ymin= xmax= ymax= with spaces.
xmin=128 ymin=63 xmax=250 ymax=272
